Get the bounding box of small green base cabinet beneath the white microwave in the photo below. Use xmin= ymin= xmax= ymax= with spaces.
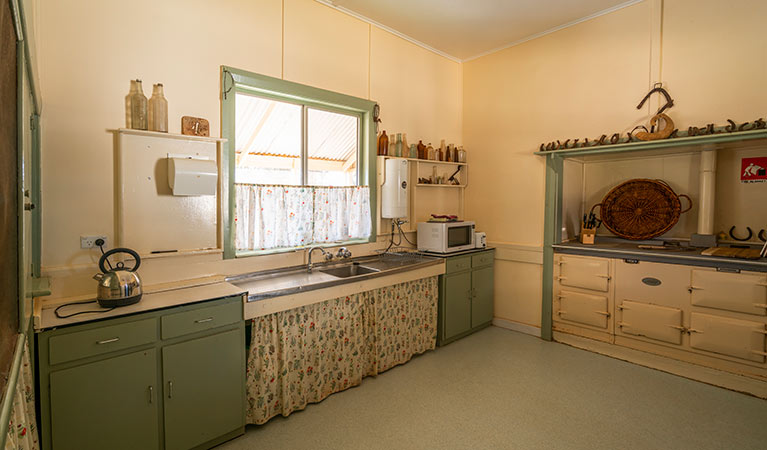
xmin=437 ymin=249 xmax=495 ymax=345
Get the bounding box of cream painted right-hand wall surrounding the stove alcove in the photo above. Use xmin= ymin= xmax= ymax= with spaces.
xmin=463 ymin=0 xmax=767 ymax=326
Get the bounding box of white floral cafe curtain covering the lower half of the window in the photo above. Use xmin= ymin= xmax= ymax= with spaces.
xmin=234 ymin=184 xmax=371 ymax=251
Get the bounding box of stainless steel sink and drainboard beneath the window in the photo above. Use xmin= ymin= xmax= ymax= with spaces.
xmin=226 ymin=254 xmax=442 ymax=302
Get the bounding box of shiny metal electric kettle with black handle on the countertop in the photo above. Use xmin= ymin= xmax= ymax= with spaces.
xmin=93 ymin=248 xmax=141 ymax=308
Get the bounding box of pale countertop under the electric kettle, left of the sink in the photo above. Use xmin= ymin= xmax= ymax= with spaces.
xmin=35 ymin=282 xmax=246 ymax=331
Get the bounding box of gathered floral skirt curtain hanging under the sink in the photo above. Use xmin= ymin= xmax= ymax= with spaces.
xmin=247 ymin=277 xmax=438 ymax=424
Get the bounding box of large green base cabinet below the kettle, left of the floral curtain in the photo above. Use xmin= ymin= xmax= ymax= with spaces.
xmin=37 ymin=296 xmax=245 ymax=450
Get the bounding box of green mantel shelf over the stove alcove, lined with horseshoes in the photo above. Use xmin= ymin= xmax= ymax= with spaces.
xmin=535 ymin=129 xmax=767 ymax=158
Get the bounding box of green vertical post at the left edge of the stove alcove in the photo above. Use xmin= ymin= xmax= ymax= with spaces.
xmin=541 ymin=155 xmax=564 ymax=341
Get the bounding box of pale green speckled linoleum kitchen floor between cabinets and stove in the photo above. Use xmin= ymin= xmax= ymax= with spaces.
xmin=219 ymin=327 xmax=767 ymax=450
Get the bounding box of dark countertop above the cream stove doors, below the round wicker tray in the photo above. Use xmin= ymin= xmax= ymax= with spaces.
xmin=552 ymin=242 xmax=767 ymax=272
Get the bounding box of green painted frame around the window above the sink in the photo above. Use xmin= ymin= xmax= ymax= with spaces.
xmin=221 ymin=66 xmax=378 ymax=259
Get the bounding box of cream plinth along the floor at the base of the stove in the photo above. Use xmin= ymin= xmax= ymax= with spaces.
xmin=554 ymin=331 xmax=767 ymax=399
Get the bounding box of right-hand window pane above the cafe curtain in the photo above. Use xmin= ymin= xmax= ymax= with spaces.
xmin=307 ymin=108 xmax=359 ymax=186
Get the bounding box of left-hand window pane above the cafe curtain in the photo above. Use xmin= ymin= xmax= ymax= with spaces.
xmin=234 ymin=94 xmax=301 ymax=185
